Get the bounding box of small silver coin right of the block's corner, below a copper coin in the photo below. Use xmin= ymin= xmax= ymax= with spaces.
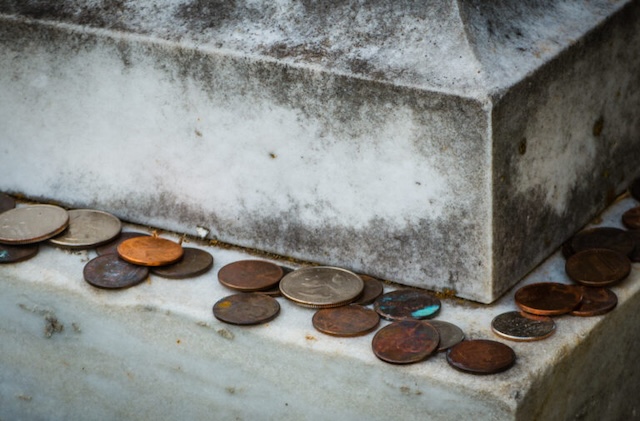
xmin=491 ymin=311 xmax=556 ymax=341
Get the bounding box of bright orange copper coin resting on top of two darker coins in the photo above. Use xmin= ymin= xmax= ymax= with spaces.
xmin=118 ymin=233 xmax=183 ymax=266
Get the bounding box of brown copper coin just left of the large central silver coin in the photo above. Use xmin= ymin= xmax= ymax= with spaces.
xmin=218 ymin=260 xmax=284 ymax=292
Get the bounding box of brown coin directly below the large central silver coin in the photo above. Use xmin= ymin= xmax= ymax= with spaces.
xmin=312 ymin=304 xmax=380 ymax=336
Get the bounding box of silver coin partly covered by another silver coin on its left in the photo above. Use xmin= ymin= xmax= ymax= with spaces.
xmin=49 ymin=209 xmax=122 ymax=249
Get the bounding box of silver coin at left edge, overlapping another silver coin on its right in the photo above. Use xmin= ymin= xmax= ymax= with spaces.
xmin=0 ymin=205 xmax=69 ymax=244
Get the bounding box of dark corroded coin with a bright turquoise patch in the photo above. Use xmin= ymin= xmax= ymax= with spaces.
xmin=374 ymin=289 xmax=440 ymax=320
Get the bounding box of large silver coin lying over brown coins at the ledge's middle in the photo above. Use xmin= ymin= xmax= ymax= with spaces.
xmin=280 ymin=266 xmax=364 ymax=308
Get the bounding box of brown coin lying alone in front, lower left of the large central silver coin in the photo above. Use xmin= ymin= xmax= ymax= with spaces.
xmin=213 ymin=292 xmax=280 ymax=325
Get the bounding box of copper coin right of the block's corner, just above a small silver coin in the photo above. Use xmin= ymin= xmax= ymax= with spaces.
xmin=515 ymin=282 xmax=582 ymax=316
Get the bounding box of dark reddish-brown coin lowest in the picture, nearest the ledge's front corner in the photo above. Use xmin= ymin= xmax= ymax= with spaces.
xmin=447 ymin=339 xmax=516 ymax=374
